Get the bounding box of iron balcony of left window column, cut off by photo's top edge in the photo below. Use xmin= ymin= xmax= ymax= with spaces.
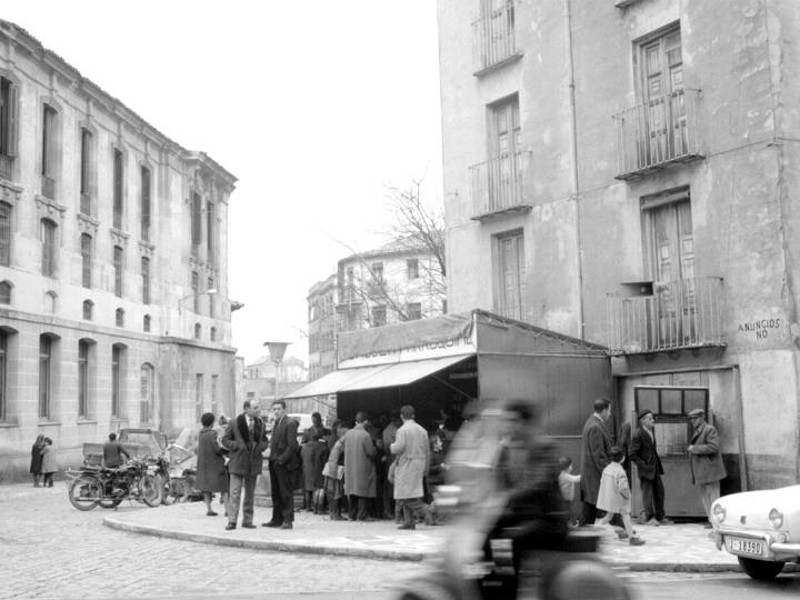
xmin=472 ymin=2 xmax=522 ymax=76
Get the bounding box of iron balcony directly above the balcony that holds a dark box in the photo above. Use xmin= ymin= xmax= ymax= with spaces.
xmin=614 ymin=89 xmax=703 ymax=179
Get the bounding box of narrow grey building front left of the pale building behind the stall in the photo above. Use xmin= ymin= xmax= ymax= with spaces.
xmin=308 ymin=275 xmax=337 ymax=381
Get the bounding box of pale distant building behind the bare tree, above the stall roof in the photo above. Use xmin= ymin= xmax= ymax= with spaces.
xmin=336 ymin=239 xmax=447 ymax=331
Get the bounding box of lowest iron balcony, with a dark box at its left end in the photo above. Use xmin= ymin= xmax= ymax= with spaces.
xmin=606 ymin=277 xmax=725 ymax=354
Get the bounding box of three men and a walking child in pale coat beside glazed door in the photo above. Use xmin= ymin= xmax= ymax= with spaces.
xmin=580 ymin=398 xmax=726 ymax=545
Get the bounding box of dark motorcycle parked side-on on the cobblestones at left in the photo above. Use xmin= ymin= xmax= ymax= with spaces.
xmin=66 ymin=458 xmax=161 ymax=511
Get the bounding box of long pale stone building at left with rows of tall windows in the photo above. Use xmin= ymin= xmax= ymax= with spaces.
xmin=0 ymin=21 xmax=236 ymax=476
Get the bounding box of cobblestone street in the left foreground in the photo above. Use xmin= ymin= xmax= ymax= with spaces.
xmin=0 ymin=482 xmax=421 ymax=600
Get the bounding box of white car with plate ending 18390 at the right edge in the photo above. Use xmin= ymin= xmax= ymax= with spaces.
xmin=711 ymin=485 xmax=800 ymax=580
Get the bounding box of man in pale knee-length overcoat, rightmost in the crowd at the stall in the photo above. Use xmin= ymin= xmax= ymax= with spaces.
xmin=389 ymin=405 xmax=433 ymax=529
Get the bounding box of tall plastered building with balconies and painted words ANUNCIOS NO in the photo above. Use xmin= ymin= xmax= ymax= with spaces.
xmin=439 ymin=0 xmax=800 ymax=495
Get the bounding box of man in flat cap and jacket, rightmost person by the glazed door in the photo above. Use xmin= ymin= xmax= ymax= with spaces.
xmin=686 ymin=408 xmax=727 ymax=527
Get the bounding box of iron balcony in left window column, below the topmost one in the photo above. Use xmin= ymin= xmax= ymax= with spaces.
xmin=469 ymin=151 xmax=533 ymax=221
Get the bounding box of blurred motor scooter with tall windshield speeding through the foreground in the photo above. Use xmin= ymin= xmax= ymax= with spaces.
xmin=397 ymin=408 xmax=630 ymax=600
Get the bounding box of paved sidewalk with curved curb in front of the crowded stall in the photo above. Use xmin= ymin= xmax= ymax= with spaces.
xmin=104 ymin=502 xmax=752 ymax=572
